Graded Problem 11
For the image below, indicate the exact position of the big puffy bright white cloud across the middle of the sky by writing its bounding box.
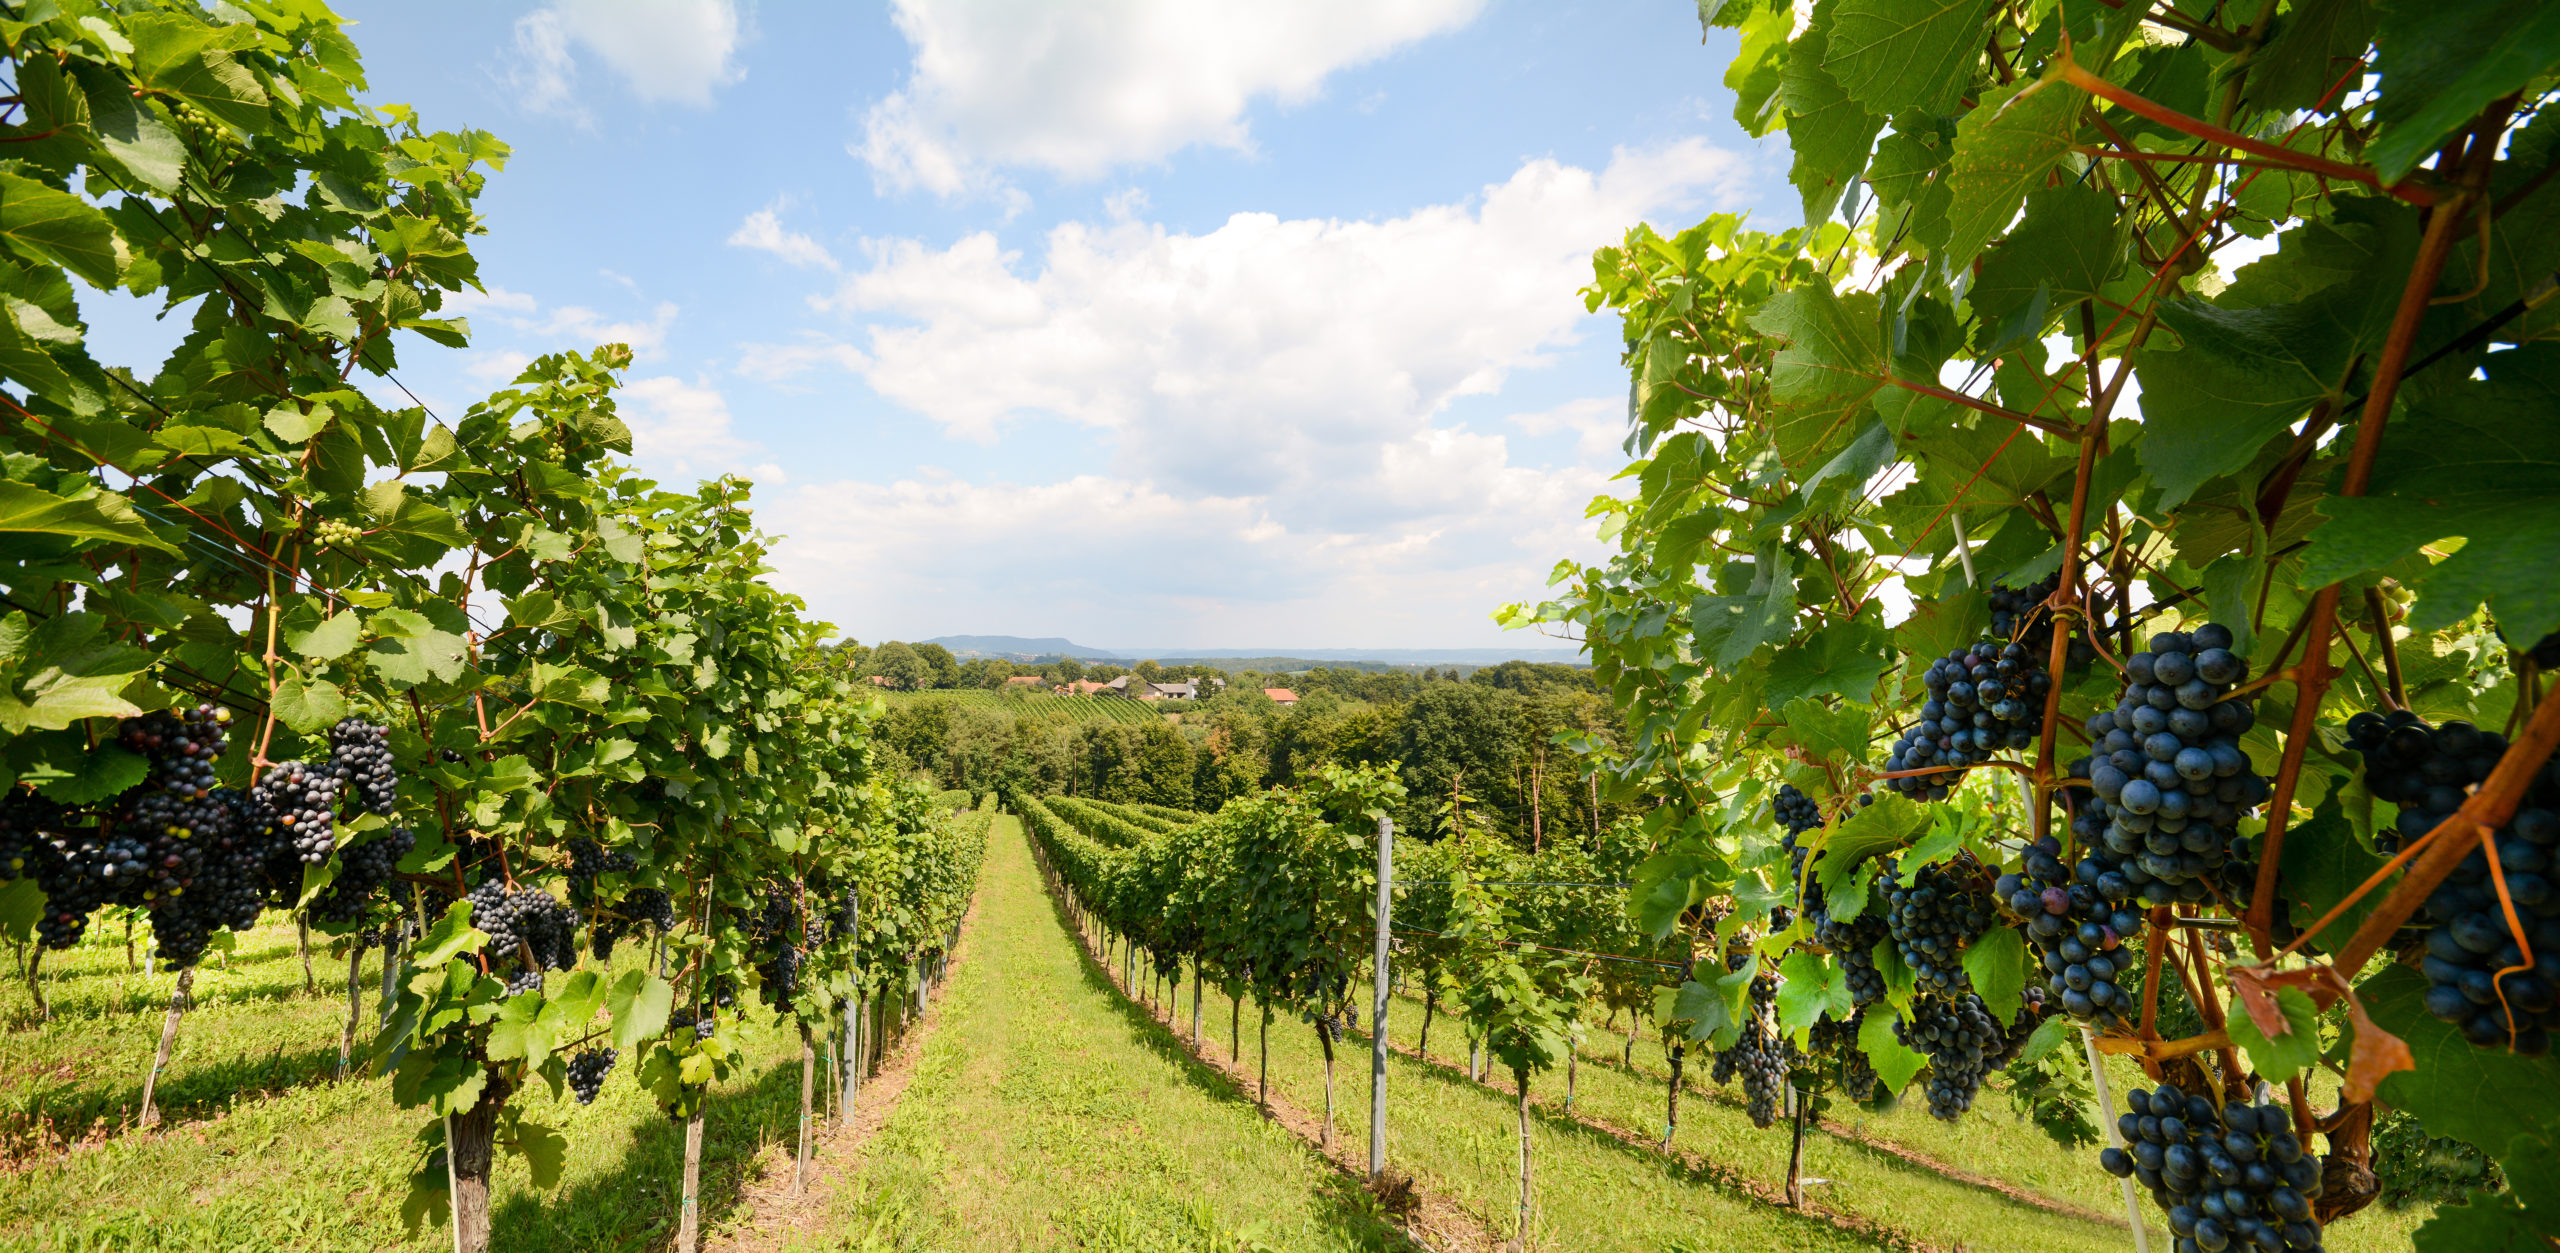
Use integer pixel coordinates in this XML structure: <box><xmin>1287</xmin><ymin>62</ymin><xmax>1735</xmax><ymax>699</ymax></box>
<box><xmin>827</xmin><ymin>141</ymin><xmax>1746</xmax><ymax>500</ymax></box>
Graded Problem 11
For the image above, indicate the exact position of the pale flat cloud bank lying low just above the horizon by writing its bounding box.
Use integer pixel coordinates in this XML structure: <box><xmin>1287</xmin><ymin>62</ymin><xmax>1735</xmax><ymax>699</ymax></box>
<box><xmin>758</xmin><ymin>441</ymin><xmax>1608</xmax><ymax>648</ymax></box>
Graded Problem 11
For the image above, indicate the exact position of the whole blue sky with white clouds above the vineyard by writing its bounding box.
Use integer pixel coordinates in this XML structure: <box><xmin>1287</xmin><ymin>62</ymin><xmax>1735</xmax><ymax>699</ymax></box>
<box><xmin>280</xmin><ymin>0</ymin><xmax>1797</xmax><ymax>648</ymax></box>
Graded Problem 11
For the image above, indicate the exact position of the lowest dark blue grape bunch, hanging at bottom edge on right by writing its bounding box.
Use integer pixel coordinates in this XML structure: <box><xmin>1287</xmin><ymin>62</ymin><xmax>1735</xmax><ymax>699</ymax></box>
<box><xmin>2097</xmin><ymin>1084</ymin><xmax>2319</xmax><ymax>1253</ymax></box>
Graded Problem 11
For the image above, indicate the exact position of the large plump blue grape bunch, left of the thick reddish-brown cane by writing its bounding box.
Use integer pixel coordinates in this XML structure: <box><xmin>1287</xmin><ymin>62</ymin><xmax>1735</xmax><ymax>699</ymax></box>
<box><xmin>2071</xmin><ymin>623</ymin><xmax>2273</xmax><ymax>905</ymax></box>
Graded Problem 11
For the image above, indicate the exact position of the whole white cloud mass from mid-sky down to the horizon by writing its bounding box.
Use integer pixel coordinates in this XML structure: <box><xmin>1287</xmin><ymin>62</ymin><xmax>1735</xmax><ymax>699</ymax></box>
<box><xmin>740</xmin><ymin>141</ymin><xmax>1746</xmax><ymax>646</ymax></box>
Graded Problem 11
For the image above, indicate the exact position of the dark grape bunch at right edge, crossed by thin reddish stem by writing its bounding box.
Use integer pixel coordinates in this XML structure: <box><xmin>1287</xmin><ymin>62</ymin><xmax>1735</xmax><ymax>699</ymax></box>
<box><xmin>2419</xmin><ymin>758</ymin><xmax>2560</xmax><ymax>1056</ymax></box>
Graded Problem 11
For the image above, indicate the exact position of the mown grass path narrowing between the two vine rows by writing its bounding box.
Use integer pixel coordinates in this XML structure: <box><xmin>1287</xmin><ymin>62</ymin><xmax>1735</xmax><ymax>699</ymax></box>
<box><xmin>794</xmin><ymin>817</ymin><xmax>1398</xmax><ymax>1253</ymax></box>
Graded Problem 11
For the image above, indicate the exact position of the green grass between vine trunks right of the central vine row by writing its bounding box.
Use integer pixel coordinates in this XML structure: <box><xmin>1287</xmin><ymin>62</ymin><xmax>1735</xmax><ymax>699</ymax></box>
<box><xmin>1185</xmin><ymin>989</ymin><xmax>2427</xmax><ymax>1253</ymax></box>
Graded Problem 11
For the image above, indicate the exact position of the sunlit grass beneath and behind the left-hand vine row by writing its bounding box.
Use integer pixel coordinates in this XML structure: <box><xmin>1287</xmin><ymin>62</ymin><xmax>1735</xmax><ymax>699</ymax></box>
<box><xmin>0</xmin><ymin>915</ymin><xmax>844</xmax><ymax>1253</ymax></box>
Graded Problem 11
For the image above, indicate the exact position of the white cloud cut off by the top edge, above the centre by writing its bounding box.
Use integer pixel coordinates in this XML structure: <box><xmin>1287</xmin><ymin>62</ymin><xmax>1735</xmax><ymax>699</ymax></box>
<box><xmin>850</xmin><ymin>0</ymin><xmax>1482</xmax><ymax>195</ymax></box>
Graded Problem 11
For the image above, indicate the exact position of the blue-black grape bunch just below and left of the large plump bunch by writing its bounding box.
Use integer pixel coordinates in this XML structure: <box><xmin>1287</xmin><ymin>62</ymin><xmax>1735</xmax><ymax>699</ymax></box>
<box><xmin>1992</xmin><ymin>835</ymin><xmax>2143</xmax><ymax>1022</ymax></box>
